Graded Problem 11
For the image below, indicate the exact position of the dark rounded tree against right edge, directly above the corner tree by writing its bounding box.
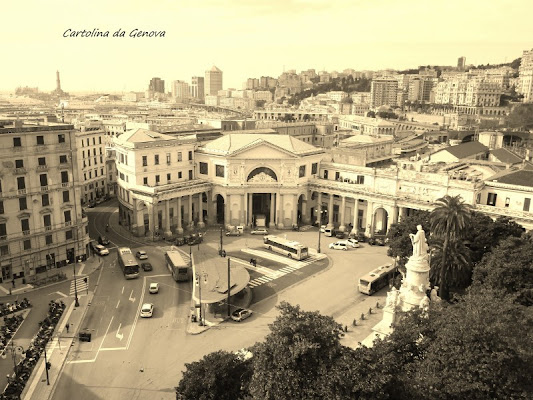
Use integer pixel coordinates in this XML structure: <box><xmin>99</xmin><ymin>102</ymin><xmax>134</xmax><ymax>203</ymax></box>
<box><xmin>472</xmin><ymin>234</ymin><xmax>533</xmax><ymax>306</ymax></box>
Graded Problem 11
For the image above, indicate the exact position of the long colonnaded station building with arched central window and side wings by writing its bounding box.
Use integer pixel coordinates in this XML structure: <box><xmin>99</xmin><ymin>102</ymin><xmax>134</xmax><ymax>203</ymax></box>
<box><xmin>114</xmin><ymin>129</ymin><xmax>533</xmax><ymax>239</ymax></box>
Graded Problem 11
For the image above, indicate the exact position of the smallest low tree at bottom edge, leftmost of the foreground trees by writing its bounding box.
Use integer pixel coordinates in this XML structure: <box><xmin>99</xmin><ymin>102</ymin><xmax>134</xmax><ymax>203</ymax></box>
<box><xmin>176</xmin><ymin>351</ymin><xmax>252</xmax><ymax>400</ymax></box>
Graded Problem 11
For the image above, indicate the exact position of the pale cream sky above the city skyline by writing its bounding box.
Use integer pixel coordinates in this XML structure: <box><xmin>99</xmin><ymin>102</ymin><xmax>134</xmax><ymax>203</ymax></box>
<box><xmin>0</xmin><ymin>0</ymin><xmax>533</xmax><ymax>93</ymax></box>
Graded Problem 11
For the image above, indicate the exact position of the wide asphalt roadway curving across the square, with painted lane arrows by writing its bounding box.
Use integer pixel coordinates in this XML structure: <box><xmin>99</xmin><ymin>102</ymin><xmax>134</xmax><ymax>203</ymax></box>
<box><xmin>53</xmin><ymin>203</ymin><xmax>389</xmax><ymax>400</ymax></box>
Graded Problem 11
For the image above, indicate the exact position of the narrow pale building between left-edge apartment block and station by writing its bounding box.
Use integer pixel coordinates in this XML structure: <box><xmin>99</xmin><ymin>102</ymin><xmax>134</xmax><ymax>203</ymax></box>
<box><xmin>76</xmin><ymin>121</ymin><xmax>108</xmax><ymax>204</ymax></box>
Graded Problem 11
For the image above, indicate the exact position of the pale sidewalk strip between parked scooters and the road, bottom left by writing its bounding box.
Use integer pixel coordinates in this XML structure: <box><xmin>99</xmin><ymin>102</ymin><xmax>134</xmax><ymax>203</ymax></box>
<box><xmin>21</xmin><ymin>292</ymin><xmax>94</xmax><ymax>400</ymax></box>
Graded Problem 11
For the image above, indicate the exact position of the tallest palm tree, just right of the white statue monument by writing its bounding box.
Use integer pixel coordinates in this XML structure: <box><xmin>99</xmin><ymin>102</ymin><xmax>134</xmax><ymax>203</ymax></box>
<box><xmin>430</xmin><ymin>195</ymin><xmax>472</xmax><ymax>300</ymax></box>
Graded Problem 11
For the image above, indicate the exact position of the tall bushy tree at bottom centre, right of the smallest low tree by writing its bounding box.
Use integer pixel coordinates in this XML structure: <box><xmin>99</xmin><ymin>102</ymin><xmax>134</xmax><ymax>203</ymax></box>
<box><xmin>250</xmin><ymin>302</ymin><xmax>343</xmax><ymax>400</ymax></box>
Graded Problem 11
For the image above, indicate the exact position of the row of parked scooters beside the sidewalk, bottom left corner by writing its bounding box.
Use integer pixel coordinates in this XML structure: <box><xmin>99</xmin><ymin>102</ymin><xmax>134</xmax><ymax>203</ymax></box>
<box><xmin>0</xmin><ymin>301</ymin><xmax>65</xmax><ymax>400</ymax></box>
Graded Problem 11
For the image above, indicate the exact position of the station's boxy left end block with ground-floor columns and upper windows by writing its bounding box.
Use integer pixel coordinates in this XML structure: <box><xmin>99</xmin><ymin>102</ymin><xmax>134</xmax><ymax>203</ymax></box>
<box><xmin>114</xmin><ymin>129</ymin><xmax>203</xmax><ymax>237</ymax></box>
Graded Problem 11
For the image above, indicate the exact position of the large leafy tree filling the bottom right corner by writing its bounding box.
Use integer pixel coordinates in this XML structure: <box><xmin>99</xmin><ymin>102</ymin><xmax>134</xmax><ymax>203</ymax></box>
<box><xmin>404</xmin><ymin>290</ymin><xmax>533</xmax><ymax>400</ymax></box>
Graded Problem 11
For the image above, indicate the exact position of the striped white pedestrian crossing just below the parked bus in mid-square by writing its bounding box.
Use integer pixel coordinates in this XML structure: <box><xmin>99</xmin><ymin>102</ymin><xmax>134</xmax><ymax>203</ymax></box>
<box><xmin>239</xmin><ymin>249</ymin><xmax>326</xmax><ymax>288</ymax></box>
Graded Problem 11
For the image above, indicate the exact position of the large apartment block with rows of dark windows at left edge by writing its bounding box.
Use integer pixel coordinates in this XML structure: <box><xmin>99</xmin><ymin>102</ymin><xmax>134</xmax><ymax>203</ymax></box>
<box><xmin>0</xmin><ymin>120</ymin><xmax>89</xmax><ymax>282</ymax></box>
